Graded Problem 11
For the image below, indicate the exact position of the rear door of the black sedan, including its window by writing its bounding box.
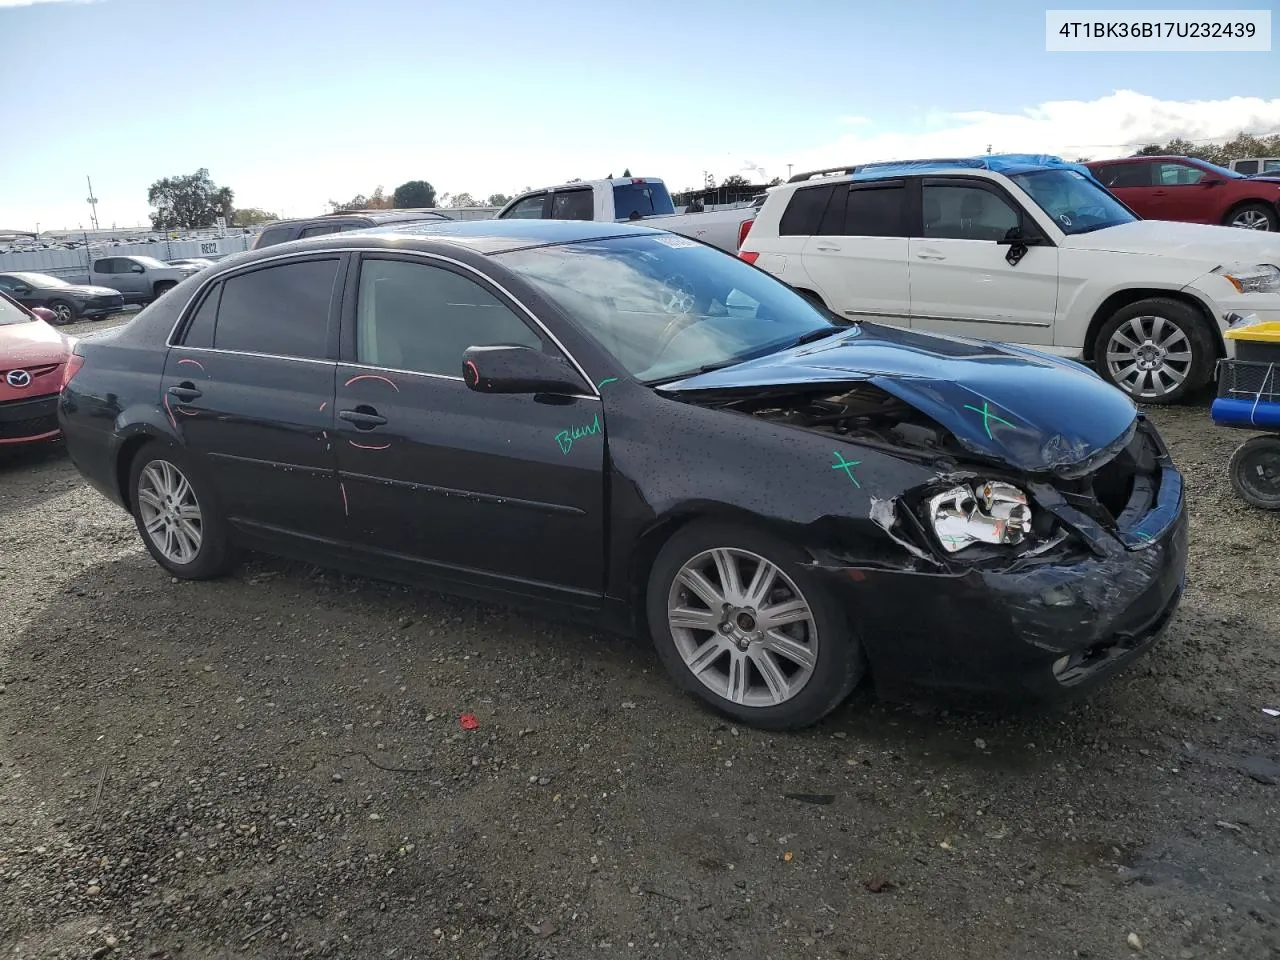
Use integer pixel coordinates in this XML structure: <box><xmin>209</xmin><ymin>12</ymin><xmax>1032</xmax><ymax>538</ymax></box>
<box><xmin>161</xmin><ymin>253</ymin><xmax>344</xmax><ymax>540</ymax></box>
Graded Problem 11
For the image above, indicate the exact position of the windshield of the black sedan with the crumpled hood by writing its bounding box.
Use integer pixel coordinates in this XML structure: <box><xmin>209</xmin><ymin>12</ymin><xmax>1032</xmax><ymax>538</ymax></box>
<box><xmin>494</xmin><ymin>234</ymin><xmax>849</xmax><ymax>384</ymax></box>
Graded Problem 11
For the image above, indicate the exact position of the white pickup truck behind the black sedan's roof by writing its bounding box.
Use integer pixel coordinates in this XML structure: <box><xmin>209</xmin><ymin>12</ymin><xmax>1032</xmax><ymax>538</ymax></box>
<box><xmin>497</xmin><ymin>177</ymin><xmax>758</xmax><ymax>253</ymax></box>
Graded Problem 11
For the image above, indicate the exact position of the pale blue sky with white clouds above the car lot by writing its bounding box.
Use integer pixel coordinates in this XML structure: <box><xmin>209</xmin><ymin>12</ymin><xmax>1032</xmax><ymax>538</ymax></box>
<box><xmin>0</xmin><ymin>0</ymin><xmax>1280</xmax><ymax>229</ymax></box>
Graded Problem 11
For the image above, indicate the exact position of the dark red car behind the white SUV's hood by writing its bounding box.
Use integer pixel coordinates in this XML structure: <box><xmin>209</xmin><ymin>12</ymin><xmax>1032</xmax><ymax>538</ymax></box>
<box><xmin>1085</xmin><ymin>156</ymin><xmax>1280</xmax><ymax>230</ymax></box>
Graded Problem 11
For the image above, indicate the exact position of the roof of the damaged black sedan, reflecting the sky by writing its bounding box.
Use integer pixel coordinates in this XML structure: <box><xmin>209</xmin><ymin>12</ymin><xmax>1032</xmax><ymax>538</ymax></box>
<box><xmin>237</xmin><ymin>219</ymin><xmax>666</xmax><ymax>264</ymax></box>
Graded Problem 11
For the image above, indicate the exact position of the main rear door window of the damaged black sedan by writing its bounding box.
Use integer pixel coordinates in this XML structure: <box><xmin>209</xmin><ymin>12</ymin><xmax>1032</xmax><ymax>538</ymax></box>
<box><xmin>214</xmin><ymin>259</ymin><xmax>339</xmax><ymax>360</ymax></box>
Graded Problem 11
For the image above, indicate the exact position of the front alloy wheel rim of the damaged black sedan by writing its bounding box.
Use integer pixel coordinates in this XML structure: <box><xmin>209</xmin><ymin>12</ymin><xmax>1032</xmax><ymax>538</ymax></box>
<box><xmin>667</xmin><ymin>548</ymin><xmax>818</xmax><ymax>707</ymax></box>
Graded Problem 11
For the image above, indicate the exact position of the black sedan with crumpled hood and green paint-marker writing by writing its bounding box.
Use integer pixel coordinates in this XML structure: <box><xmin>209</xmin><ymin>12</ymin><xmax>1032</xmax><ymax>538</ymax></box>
<box><xmin>59</xmin><ymin>220</ymin><xmax>1187</xmax><ymax>728</ymax></box>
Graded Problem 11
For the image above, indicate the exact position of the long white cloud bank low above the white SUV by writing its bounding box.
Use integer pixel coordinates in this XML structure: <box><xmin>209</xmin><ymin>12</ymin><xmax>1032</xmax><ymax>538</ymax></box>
<box><xmin>756</xmin><ymin>90</ymin><xmax>1280</xmax><ymax>181</ymax></box>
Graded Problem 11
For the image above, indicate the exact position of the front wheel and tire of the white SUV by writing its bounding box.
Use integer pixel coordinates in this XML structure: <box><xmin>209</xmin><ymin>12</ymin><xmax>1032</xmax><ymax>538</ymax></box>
<box><xmin>1093</xmin><ymin>297</ymin><xmax>1215</xmax><ymax>404</ymax></box>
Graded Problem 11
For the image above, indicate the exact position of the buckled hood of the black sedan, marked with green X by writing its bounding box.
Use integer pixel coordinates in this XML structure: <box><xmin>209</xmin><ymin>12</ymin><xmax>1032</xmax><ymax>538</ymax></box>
<box><xmin>658</xmin><ymin>324</ymin><xmax>1137</xmax><ymax>472</ymax></box>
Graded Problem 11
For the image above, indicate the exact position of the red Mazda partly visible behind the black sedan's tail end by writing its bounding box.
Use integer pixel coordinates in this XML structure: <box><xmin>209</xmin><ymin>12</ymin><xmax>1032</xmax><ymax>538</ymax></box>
<box><xmin>0</xmin><ymin>293</ymin><xmax>72</xmax><ymax>447</ymax></box>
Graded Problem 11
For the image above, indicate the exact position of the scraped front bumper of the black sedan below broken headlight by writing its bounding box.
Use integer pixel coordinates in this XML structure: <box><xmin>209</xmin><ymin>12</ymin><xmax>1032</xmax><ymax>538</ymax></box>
<box><xmin>817</xmin><ymin>448</ymin><xmax>1188</xmax><ymax>703</ymax></box>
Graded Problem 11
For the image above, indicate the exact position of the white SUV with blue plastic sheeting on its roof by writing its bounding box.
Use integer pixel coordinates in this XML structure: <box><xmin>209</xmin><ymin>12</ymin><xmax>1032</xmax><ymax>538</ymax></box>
<box><xmin>739</xmin><ymin>155</ymin><xmax>1280</xmax><ymax>403</ymax></box>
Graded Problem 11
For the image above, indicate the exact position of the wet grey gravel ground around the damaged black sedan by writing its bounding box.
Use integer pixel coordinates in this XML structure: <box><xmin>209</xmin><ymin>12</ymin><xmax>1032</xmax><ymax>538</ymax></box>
<box><xmin>0</xmin><ymin>317</ymin><xmax>1280</xmax><ymax>960</ymax></box>
